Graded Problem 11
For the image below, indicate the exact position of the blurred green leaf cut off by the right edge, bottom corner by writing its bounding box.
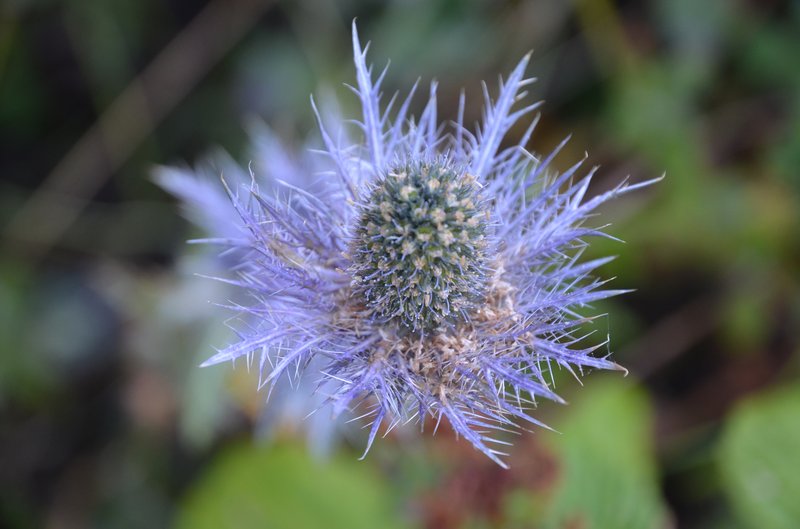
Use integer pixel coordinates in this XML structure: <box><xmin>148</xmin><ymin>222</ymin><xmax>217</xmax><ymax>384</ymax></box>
<box><xmin>720</xmin><ymin>385</ymin><xmax>800</xmax><ymax>529</ymax></box>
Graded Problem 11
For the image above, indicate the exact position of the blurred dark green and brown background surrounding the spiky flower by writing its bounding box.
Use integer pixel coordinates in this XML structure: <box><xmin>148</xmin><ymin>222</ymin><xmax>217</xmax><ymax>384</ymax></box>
<box><xmin>0</xmin><ymin>0</ymin><xmax>800</xmax><ymax>529</ymax></box>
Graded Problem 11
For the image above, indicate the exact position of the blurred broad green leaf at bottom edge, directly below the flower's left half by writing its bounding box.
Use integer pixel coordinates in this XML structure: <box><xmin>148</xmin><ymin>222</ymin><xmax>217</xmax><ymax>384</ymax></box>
<box><xmin>176</xmin><ymin>445</ymin><xmax>412</xmax><ymax>529</ymax></box>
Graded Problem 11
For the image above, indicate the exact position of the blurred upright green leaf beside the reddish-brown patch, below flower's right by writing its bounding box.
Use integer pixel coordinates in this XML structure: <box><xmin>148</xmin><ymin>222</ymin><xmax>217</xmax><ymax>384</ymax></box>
<box><xmin>543</xmin><ymin>377</ymin><xmax>669</xmax><ymax>529</ymax></box>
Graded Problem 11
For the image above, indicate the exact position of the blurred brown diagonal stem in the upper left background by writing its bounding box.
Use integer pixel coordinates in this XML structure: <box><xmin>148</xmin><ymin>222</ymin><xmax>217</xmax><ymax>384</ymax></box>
<box><xmin>5</xmin><ymin>0</ymin><xmax>272</xmax><ymax>257</ymax></box>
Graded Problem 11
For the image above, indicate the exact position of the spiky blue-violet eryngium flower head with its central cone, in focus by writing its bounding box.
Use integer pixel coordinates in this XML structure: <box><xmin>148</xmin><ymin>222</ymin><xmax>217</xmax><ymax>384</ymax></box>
<box><xmin>169</xmin><ymin>25</ymin><xmax>650</xmax><ymax>466</ymax></box>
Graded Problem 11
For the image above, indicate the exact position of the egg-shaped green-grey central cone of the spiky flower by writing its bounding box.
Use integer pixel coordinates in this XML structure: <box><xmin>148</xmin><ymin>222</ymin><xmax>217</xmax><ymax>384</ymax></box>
<box><xmin>350</xmin><ymin>162</ymin><xmax>488</xmax><ymax>333</ymax></box>
